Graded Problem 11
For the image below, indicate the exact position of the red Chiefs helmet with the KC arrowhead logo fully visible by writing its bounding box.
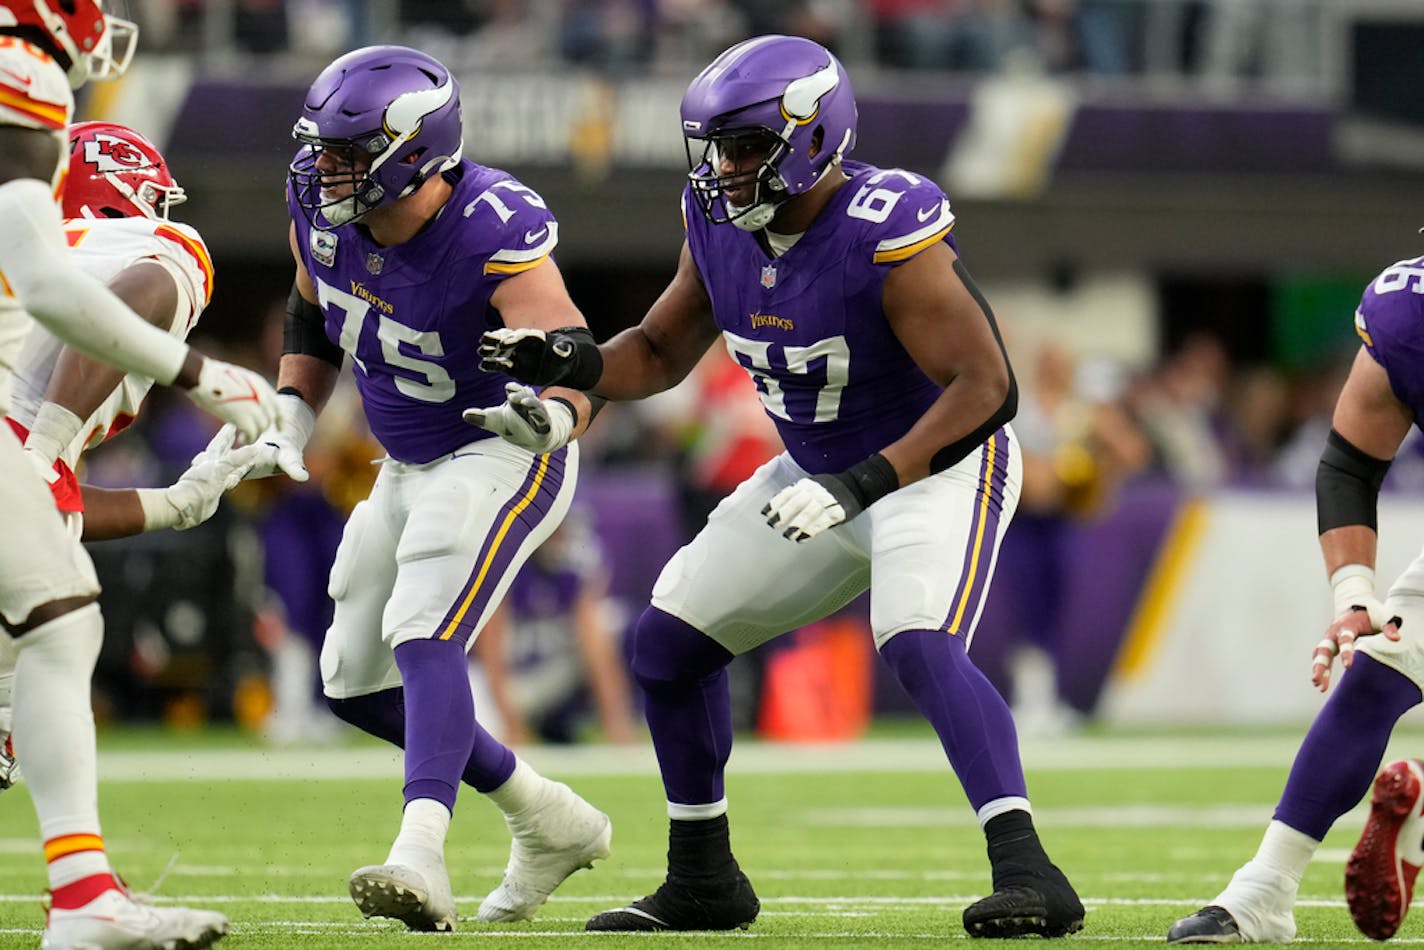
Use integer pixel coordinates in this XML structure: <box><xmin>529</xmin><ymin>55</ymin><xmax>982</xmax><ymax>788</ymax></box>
<box><xmin>60</xmin><ymin>122</ymin><xmax>188</xmax><ymax>221</ymax></box>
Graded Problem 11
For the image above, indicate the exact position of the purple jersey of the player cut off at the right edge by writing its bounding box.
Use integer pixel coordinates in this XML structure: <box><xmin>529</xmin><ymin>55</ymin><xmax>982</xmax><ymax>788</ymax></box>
<box><xmin>1354</xmin><ymin>258</ymin><xmax>1424</xmax><ymax>420</ymax></box>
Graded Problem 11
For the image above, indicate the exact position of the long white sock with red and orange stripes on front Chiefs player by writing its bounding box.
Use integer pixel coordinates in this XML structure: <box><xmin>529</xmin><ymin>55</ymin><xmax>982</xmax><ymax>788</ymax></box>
<box><xmin>13</xmin><ymin>604</ymin><xmax>110</xmax><ymax>889</ymax></box>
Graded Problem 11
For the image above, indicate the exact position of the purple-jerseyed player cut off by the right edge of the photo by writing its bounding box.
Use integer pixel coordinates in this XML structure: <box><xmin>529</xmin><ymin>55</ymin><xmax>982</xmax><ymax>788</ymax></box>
<box><xmin>1168</xmin><ymin>258</ymin><xmax>1424</xmax><ymax>943</ymax></box>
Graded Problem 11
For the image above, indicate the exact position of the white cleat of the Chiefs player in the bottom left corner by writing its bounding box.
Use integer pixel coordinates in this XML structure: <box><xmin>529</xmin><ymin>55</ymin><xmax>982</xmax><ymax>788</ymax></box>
<box><xmin>40</xmin><ymin>890</ymin><xmax>228</xmax><ymax>950</ymax></box>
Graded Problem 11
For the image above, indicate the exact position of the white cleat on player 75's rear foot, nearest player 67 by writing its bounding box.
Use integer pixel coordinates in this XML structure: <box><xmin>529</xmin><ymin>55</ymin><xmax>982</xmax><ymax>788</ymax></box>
<box><xmin>478</xmin><ymin>781</ymin><xmax>614</xmax><ymax>923</ymax></box>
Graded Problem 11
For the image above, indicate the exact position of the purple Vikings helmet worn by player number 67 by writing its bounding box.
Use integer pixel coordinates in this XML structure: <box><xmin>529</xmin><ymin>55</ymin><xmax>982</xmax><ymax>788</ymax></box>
<box><xmin>682</xmin><ymin>36</ymin><xmax>856</xmax><ymax>231</ymax></box>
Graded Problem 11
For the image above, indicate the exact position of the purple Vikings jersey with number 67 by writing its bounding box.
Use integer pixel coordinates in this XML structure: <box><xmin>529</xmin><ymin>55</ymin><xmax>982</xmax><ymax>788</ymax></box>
<box><xmin>682</xmin><ymin>161</ymin><xmax>954</xmax><ymax>474</ymax></box>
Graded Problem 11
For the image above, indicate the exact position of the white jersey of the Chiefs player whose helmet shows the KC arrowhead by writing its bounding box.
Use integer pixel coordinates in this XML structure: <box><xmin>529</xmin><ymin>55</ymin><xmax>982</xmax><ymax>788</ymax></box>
<box><xmin>10</xmin><ymin>218</ymin><xmax>212</xmax><ymax>467</ymax></box>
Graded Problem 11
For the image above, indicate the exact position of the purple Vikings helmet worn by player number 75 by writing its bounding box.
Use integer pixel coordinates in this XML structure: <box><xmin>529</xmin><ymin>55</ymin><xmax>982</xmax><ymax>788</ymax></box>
<box><xmin>290</xmin><ymin>46</ymin><xmax>464</xmax><ymax>226</ymax></box>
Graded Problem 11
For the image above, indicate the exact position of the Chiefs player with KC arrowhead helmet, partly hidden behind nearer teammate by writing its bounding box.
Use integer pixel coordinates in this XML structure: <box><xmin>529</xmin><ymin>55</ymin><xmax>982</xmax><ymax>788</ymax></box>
<box><xmin>0</xmin><ymin>122</ymin><xmax>256</xmax><ymax>789</ymax></box>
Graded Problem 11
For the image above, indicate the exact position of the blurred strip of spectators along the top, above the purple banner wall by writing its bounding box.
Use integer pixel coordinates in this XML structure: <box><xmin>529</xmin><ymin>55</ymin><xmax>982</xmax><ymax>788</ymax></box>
<box><xmin>131</xmin><ymin>0</ymin><xmax>1324</xmax><ymax>87</ymax></box>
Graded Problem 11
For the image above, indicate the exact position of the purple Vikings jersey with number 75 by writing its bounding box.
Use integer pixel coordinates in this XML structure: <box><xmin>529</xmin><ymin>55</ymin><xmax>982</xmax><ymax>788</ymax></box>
<box><xmin>288</xmin><ymin>160</ymin><xmax>558</xmax><ymax>463</ymax></box>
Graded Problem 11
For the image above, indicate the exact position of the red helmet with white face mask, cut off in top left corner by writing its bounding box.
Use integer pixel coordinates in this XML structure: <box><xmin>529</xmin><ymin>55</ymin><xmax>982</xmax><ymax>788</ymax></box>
<box><xmin>0</xmin><ymin>0</ymin><xmax>138</xmax><ymax>88</ymax></box>
